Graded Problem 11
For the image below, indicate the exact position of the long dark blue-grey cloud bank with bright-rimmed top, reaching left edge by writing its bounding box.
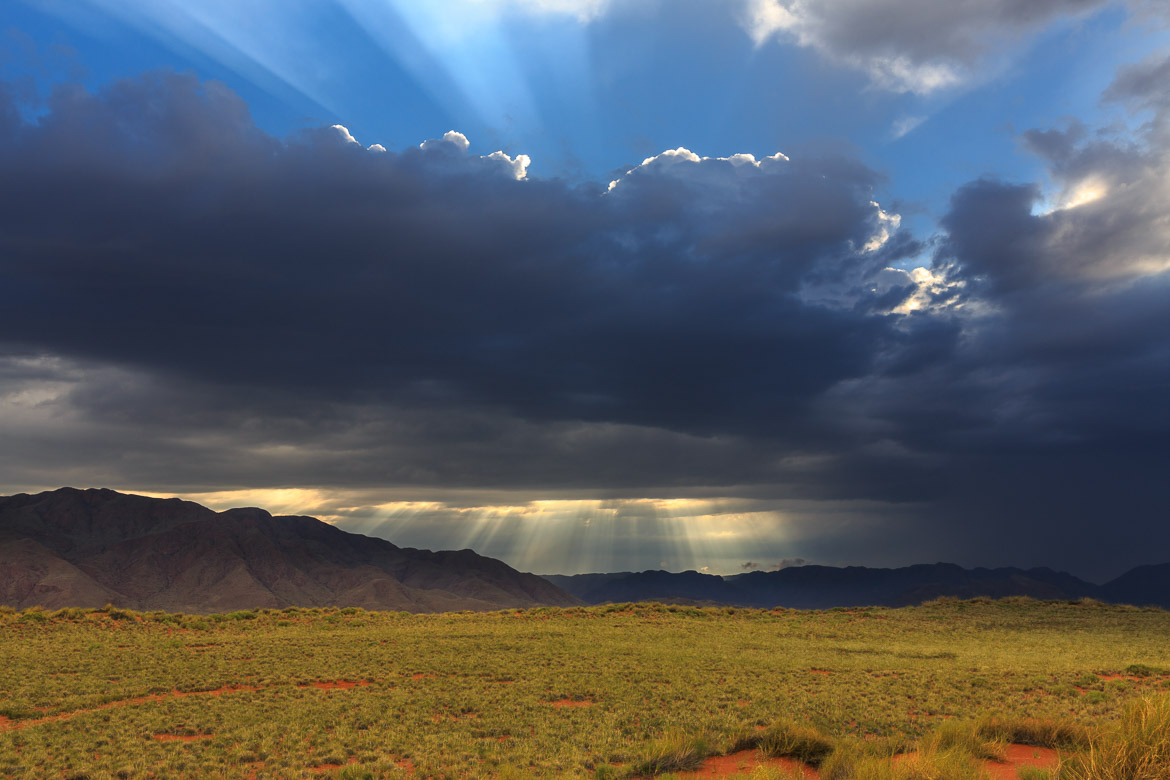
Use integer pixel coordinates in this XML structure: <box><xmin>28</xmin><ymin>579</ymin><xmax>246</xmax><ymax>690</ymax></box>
<box><xmin>0</xmin><ymin>74</ymin><xmax>903</xmax><ymax>444</ymax></box>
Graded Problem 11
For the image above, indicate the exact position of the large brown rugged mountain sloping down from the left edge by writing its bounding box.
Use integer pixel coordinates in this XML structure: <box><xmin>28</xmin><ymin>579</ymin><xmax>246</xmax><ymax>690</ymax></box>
<box><xmin>0</xmin><ymin>488</ymin><xmax>580</xmax><ymax>613</ymax></box>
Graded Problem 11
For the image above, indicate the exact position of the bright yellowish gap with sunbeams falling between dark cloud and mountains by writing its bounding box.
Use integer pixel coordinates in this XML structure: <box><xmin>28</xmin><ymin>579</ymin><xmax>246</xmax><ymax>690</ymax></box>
<box><xmin>140</xmin><ymin>489</ymin><xmax>787</xmax><ymax>574</ymax></box>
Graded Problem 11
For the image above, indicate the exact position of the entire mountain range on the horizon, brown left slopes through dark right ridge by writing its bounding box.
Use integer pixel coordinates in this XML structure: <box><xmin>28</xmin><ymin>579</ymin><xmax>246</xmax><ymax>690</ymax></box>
<box><xmin>0</xmin><ymin>488</ymin><xmax>1170</xmax><ymax>613</ymax></box>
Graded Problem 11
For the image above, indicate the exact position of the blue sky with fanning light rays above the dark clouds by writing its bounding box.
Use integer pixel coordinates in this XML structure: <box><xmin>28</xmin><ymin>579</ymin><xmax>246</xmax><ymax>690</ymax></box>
<box><xmin>0</xmin><ymin>0</ymin><xmax>1170</xmax><ymax>206</ymax></box>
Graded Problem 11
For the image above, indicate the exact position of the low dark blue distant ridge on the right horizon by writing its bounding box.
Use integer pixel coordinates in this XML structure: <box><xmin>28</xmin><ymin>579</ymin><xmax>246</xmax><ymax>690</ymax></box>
<box><xmin>545</xmin><ymin>564</ymin><xmax>1170</xmax><ymax>609</ymax></box>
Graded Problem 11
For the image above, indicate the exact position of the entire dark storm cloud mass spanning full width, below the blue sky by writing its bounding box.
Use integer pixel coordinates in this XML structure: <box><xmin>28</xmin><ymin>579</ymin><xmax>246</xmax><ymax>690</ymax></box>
<box><xmin>0</xmin><ymin>68</ymin><xmax>1170</xmax><ymax>574</ymax></box>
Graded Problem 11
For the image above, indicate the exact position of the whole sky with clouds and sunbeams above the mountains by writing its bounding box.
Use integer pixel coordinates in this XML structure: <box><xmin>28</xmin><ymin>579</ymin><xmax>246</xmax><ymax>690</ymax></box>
<box><xmin>0</xmin><ymin>0</ymin><xmax>1170</xmax><ymax>581</ymax></box>
